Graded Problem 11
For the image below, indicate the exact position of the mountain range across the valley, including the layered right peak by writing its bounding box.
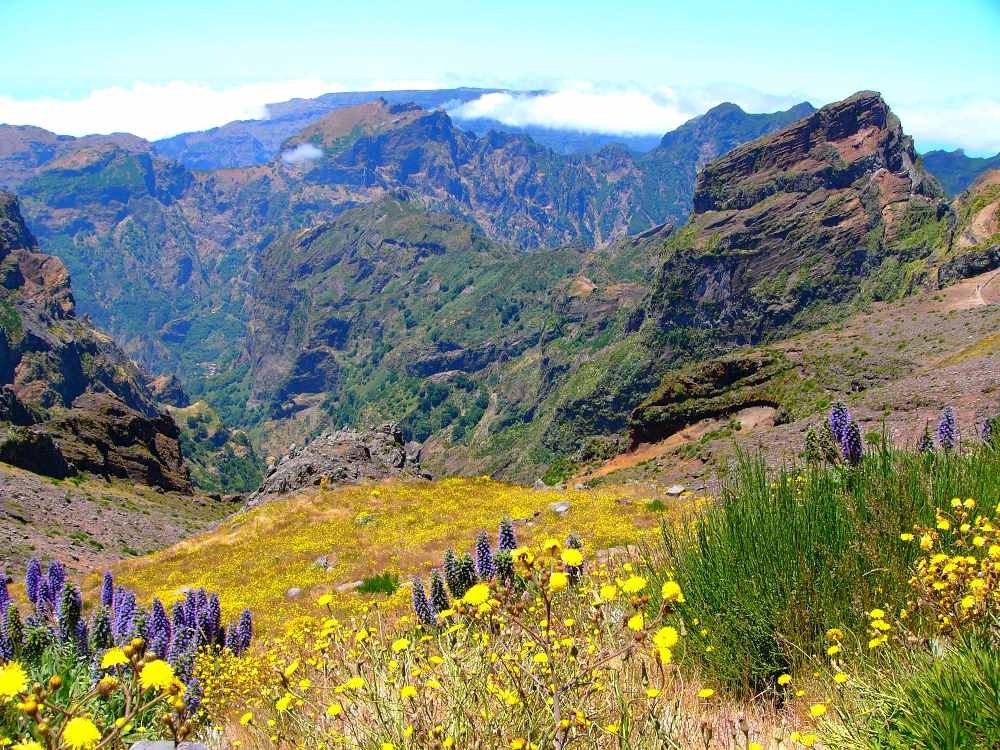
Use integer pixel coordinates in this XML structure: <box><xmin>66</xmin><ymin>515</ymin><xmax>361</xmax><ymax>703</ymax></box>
<box><xmin>0</xmin><ymin>90</ymin><xmax>1000</xmax><ymax>490</ymax></box>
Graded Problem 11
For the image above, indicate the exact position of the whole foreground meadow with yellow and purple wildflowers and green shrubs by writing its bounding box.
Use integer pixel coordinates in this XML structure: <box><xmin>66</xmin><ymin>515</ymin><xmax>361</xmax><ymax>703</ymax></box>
<box><xmin>0</xmin><ymin>404</ymin><xmax>1000</xmax><ymax>750</ymax></box>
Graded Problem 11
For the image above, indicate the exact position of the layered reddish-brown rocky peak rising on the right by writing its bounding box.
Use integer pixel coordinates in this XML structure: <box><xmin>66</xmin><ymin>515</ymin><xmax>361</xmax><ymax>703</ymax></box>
<box><xmin>649</xmin><ymin>92</ymin><xmax>948</xmax><ymax>343</ymax></box>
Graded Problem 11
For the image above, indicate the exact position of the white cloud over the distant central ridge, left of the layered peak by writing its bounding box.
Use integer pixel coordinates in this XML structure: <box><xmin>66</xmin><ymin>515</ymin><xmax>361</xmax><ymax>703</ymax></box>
<box><xmin>452</xmin><ymin>82</ymin><xmax>804</xmax><ymax>135</ymax></box>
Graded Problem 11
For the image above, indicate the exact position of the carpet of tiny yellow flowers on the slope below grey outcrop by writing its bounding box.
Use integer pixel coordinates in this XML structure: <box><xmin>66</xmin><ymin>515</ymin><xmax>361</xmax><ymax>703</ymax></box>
<box><xmin>105</xmin><ymin>477</ymin><xmax>700</xmax><ymax>633</ymax></box>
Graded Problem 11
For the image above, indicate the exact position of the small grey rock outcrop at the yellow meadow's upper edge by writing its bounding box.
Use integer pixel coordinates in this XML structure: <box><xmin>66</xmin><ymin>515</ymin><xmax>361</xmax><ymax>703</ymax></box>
<box><xmin>247</xmin><ymin>424</ymin><xmax>428</xmax><ymax>507</ymax></box>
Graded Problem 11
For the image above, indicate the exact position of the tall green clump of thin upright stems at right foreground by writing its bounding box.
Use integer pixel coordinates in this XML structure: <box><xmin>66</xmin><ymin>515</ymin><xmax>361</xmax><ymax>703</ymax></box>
<box><xmin>654</xmin><ymin>441</ymin><xmax>1000</xmax><ymax>695</ymax></box>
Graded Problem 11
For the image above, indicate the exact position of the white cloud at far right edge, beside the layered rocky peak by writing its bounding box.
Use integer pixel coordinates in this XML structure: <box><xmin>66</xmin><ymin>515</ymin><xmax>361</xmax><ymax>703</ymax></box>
<box><xmin>893</xmin><ymin>99</ymin><xmax>1000</xmax><ymax>155</ymax></box>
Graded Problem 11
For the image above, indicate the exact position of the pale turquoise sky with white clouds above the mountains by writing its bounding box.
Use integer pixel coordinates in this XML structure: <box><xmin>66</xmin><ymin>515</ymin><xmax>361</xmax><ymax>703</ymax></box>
<box><xmin>0</xmin><ymin>0</ymin><xmax>1000</xmax><ymax>153</ymax></box>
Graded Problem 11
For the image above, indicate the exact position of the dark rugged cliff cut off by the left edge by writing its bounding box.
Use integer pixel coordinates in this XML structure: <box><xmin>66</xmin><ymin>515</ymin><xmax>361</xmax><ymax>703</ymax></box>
<box><xmin>0</xmin><ymin>193</ymin><xmax>191</xmax><ymax>491</ymax></box>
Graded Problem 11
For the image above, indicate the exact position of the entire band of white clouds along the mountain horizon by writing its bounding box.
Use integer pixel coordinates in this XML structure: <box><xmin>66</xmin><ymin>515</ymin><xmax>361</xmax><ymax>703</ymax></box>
<box><xmin>0</xmin><ymin>79</ymin><xmax>1000</xmax><ymax>155</ymax></box>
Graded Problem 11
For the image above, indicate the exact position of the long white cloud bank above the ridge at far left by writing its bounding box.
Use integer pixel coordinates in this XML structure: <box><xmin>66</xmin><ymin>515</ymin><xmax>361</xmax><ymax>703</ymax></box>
<box><xmin>0</xmin><ymin>79</ymin><xmax>343</xmax><ymax>140</ymax></box>
